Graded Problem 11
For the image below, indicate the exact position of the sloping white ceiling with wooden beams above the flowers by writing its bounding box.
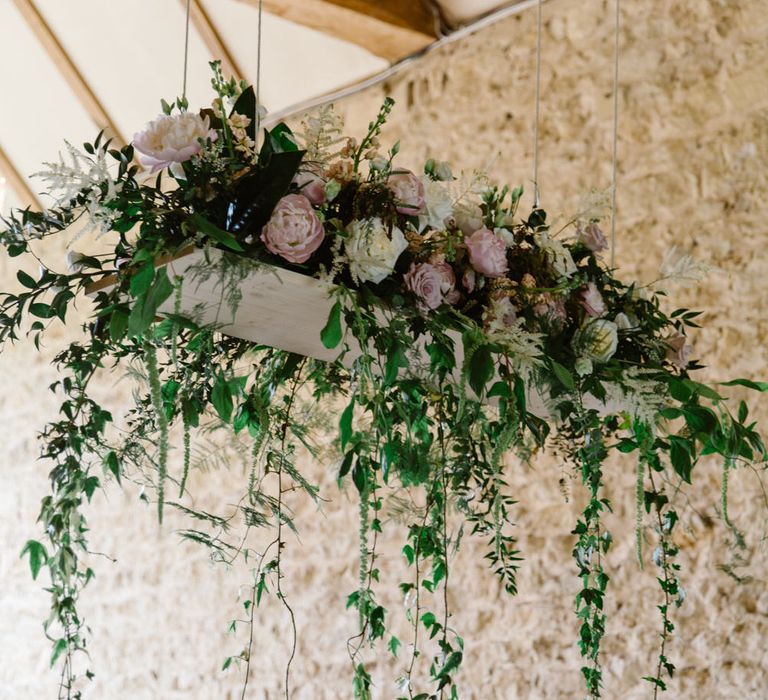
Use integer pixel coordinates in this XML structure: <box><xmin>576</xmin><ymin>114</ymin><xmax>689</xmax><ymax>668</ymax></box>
<box><xmin>0</xmin><ymin>0</ymin><xmax>514</xmax><ymax>212</ymax></box>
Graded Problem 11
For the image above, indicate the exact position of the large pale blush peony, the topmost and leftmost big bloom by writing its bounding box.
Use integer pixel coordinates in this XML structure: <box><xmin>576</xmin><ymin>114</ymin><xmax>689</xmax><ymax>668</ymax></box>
<box><xmin>133</xmin><ymin>112</ymin><xmax>216</xmax><ymax>178</ymax></box>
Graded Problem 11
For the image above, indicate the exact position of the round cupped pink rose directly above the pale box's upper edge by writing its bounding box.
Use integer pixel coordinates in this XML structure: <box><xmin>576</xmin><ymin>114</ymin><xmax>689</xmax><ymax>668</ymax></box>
<box><xmin>261</xmin><ymin>194</ymin><xmax>325</xmax><ymax>263</ymax></box>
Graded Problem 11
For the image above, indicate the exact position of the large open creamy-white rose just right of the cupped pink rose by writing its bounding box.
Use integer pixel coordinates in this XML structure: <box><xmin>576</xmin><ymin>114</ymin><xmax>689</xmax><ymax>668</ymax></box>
<box><xmin>345</xmin><ymin>217</ymin><xmax>408</xmax><ymax>284</ymax></box>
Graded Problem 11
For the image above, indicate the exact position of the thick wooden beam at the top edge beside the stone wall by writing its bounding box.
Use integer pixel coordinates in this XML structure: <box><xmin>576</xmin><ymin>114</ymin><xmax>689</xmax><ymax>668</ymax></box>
<box><xmin>241</xmin><ymin>0</ymin><xmax>435</xmax><ymax>63</ymax></box>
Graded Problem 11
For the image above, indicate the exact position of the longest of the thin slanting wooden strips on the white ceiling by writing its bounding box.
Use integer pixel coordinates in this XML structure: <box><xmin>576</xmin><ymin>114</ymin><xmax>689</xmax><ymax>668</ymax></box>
<box><xmin>13</xmin><ymin>0</ymin><xmax>125</xmax><ymax>145</ymax></box>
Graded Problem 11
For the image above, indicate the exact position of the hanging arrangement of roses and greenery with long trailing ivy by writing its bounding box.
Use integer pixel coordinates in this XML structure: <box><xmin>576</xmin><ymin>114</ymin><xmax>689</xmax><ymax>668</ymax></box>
<box><xmin>0</xmin><ymin>64</ymin><xmax>768</xmax><ymax>700</ymax></box>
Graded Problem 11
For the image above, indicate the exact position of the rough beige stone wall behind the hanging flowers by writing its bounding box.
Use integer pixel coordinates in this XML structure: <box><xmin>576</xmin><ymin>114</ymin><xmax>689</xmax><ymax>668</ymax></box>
<box><xmin>0</xmin><ymin>0</ymin><xmax>768</xmax><ymax>700</ymax></box>
